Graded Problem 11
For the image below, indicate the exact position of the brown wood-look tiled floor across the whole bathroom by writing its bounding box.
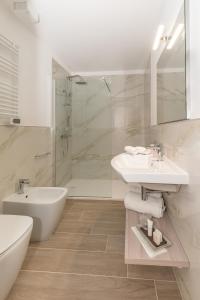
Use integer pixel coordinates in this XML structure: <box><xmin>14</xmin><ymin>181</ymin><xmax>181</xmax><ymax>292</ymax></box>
<box><xmin>7</xmin><ymin>200</ymin><xmax>181</xmax><ymax>300</ymax></box>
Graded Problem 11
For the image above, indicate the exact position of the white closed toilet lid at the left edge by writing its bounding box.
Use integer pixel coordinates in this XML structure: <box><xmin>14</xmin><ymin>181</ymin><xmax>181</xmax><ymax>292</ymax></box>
<box><xmin>0</xmin><ymin>215</ymin><xmax>33</xmax><ymax>255</ymax></box>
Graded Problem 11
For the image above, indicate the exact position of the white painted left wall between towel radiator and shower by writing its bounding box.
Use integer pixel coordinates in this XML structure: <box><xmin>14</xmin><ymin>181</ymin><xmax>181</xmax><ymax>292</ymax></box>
<box><xmin>0</xmin><ymin>3</ymin><xmax>65</xmax><ymax>126</ymax></box>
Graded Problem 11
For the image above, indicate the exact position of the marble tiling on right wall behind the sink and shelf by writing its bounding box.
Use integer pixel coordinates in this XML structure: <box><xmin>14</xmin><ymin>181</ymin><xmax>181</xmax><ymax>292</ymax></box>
<box><xmin>146</xmin><ymin>120</ymin><xmax>200</xmax><ymax>300</ymax></box>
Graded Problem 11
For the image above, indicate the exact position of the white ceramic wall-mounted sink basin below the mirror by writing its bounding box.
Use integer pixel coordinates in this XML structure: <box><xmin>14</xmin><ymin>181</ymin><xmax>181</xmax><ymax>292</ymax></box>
<box><xmin>111</xmin><ymin>153</ymin><xmax>189</xmax><ymax>185</ymax></box>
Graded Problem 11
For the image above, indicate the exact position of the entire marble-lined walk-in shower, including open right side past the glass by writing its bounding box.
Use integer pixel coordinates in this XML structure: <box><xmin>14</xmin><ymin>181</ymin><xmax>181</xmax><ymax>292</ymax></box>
<box><xmin>54</xmin><ymin>62</ymin><xmax>145</xmax><ymax>199</ymax></box>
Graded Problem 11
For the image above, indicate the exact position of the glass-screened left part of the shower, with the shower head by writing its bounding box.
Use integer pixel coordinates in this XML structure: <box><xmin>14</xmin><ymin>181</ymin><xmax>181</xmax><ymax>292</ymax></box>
<box><xmin>54</xmin><ymin>75</ymin><xmax>112</xmax><ymax>198</ymax></box>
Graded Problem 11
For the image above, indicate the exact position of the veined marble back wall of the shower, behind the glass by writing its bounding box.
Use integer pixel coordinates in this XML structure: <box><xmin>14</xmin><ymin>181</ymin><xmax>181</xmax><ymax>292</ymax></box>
<box><xmin>72</xmin><ymin>75</ymin><xmax>144</xmax><ymax>185</ymax></box>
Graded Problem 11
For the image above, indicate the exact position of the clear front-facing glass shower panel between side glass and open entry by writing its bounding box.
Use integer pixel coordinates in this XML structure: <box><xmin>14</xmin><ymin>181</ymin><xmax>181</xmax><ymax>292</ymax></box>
<box><xmin>70</xmin><ymin>77</ymin><xmax>112</xmax><ymax>198</ymax></box>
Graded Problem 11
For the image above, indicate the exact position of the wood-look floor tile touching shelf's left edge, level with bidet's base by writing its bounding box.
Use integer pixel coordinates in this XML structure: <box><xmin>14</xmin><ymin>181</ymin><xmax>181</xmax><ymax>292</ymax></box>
<box><xmin>91</xmin><ymin>222</ymin><xmax>125</xmax><ymax>235</ymax></box>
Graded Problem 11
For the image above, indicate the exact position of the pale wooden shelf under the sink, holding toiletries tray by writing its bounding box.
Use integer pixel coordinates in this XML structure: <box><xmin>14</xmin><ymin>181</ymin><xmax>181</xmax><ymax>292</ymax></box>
<box><xmin>125</xmin><ymin>210</ymin><xmax>190</xmax><ymax>268</ymax></box>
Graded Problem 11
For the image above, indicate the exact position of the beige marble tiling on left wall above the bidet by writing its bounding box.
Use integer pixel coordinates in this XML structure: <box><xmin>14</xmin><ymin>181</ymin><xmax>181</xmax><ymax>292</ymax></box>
<box><xmin>0</xmin><ymin>126</ymin><xmax>53</xmax><ymax>210</ymax></box>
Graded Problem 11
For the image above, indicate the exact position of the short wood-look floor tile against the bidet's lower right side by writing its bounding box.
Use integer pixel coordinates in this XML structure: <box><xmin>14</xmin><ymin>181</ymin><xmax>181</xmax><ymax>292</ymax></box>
<box><xmin>56</xmin><ymin>220</ymin><xmax>93</xmax><ymax>233</ymax></box>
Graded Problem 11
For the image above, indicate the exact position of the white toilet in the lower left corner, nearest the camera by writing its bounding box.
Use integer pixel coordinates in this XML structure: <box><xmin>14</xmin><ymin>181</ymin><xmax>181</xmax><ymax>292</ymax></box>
<box><xmin>0</xmin><ymin>215</ymin><xmax>33</xmax><ymax>300</ymax></box>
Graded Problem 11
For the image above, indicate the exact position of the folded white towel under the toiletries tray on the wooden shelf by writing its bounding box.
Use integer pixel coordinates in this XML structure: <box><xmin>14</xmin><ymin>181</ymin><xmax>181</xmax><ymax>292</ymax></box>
<box><xmin>131</xmin><ymin>226</ymin><xmax>167</xmax><ymax>258</ymax></box>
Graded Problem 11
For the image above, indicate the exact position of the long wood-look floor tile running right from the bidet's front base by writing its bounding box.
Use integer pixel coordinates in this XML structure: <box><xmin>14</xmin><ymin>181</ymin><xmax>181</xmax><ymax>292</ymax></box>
<box><xmin>31</xmin><ymin>232</ymin><xmax>107</xmax><ymax>251</ymax></box>
